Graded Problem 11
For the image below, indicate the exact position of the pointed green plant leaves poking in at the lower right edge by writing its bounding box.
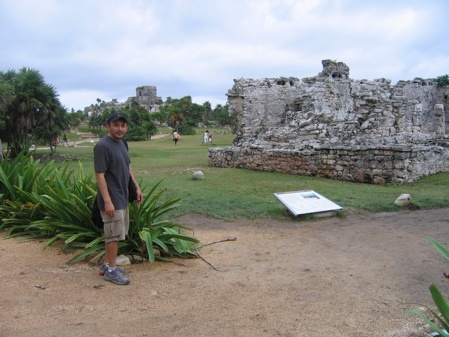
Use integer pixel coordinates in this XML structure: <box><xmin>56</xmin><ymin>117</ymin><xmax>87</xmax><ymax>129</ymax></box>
<box><xmin>407</xmin><ymin>237</ymin><xmax>449</xmax><ymax>337</ymax></box>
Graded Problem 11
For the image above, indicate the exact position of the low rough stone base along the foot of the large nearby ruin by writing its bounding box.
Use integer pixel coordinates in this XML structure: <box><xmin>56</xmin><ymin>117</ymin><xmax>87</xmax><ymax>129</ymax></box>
<box><xmin>209</xmin><ymin>144</ymin><xmax>449</xmax><ymax>184</ymax></box>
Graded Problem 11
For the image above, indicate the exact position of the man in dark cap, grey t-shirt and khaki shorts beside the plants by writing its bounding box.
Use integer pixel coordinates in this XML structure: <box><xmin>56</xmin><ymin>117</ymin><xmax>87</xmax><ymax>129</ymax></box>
<box><xmin>94</xmin><ymin>113</ymin><xmax>143</xmax><ymax>285</ymax></box>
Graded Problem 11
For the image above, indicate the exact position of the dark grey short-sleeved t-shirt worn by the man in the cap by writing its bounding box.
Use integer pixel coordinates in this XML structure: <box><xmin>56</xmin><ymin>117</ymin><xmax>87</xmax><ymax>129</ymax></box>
<box><xmin>94</xmin><ymin>136</ymin><xmax>131</xmax><ymax>211</ymax></box>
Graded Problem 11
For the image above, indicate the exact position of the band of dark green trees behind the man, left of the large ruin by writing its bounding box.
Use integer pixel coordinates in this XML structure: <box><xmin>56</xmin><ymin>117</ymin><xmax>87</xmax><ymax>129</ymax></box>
<box><xmin>0</xmin><ymin>67</ymin><xmax>235</xmax><ymax>157</ymax></box>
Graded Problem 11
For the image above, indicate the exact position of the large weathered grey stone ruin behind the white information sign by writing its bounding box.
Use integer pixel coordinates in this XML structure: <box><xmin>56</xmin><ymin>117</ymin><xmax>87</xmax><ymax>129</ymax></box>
<box><xmin>209</xmin><ymin>60</ymin><xmax>449</xmax><ymax>184</ymax></box>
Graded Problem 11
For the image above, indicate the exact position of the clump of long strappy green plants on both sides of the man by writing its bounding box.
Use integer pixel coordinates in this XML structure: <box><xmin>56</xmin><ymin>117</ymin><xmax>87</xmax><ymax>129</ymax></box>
<box><xmin>0</xmin><ymin>154</ymin><xmax>198</xmax><ymax>263</ymax></box>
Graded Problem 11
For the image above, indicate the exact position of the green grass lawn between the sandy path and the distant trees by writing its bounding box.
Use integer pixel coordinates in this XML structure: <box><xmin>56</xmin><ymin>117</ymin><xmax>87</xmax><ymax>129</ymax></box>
<box><xmin>34</xmin><ymin>129</ymin><xmax>449</xmax><ymax>220</ymax></box>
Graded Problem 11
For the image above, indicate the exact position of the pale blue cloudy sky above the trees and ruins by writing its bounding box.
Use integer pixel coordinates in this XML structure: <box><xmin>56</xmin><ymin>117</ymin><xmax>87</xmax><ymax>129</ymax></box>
<box><xmin>0</xmin><ymin>0</ymin><xmax>449</xmax><ymax>110</ymax></box>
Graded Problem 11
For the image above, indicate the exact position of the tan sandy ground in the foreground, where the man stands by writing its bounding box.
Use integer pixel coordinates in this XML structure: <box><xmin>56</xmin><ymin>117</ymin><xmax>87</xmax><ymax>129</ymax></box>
<box><xmin>0</xmin><ymin>209</ymin><xmax>449</xmax><ymax>337</ymax></box>
